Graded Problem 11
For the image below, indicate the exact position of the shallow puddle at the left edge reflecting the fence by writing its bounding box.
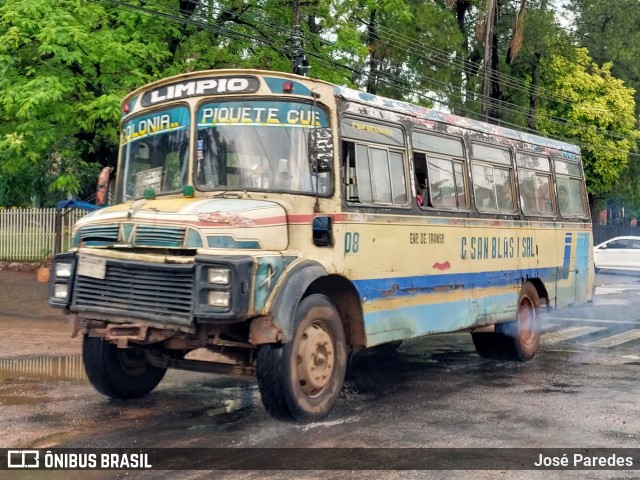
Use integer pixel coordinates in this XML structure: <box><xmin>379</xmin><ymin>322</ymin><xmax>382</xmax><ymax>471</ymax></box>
<box><xmin>0</xmin><ymin>355</ymin><xmax>88</xmax><ymax>382</ymax></box>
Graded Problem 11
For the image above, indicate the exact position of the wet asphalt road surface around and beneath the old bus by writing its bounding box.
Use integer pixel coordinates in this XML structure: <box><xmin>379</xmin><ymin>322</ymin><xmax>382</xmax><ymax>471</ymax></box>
<box><xmin>0</xmin><ymin>271</ymin><xmax>640</xmax><ymax>479</ymax></box>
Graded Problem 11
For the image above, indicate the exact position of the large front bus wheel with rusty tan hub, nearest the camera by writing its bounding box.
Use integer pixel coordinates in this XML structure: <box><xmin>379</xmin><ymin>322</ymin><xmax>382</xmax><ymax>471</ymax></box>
<box><xmin>257</xmin><ymin>294</ymin><xmax>347</xmax><ymax>421</ymax></box>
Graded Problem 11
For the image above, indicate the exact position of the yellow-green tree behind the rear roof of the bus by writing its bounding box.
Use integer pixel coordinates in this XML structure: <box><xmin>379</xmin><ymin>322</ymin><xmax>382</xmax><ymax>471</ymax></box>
<box><xmin>537</xmin><ymin>48</ymin><xmax>640</xmax><ymax>204</ymax></box>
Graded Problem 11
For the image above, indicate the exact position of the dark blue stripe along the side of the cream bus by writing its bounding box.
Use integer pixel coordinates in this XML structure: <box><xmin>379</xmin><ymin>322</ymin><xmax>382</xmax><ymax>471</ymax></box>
<box><xmin>353</xmin><ymin>267</ymin><xmax>556</xmax><ymax>302</ymax></box>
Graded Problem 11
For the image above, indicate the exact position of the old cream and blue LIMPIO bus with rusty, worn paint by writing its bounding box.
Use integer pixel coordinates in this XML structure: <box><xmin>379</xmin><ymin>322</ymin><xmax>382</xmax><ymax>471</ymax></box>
<box><xmin>49</xmin><ymin>69</ymin><xmax>594</xmax><ymax>421</ymax></box>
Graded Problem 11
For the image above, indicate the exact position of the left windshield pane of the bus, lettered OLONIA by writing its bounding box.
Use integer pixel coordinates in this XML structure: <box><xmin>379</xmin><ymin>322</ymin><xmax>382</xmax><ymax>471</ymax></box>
<box><xmin>121</xmin><ymin>106</ymin><xmax>189</xmax><ymax>201</ymax></box>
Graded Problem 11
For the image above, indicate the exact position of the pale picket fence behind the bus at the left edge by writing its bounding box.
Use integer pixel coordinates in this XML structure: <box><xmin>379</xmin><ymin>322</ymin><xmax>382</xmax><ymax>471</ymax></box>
<box><xmin>0</xmin><ymin>208</ymin><xmax>88</xmax><ymax>262</ymax></box>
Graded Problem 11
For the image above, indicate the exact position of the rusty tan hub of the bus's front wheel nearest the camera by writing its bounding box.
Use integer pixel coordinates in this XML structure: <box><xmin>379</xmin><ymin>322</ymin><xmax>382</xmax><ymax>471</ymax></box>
<box><xmin>297</xmin><ymin>323</ymin><xmax>335</xmax><ymax>397</ymax></box>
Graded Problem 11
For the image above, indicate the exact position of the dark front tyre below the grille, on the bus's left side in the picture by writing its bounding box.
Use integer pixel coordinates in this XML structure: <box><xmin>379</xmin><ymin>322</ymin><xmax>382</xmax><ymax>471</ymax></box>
<box><xmin>82</xmin><ymin>335</ymin><xmax>167</xmax><ymax>400</ymax></box>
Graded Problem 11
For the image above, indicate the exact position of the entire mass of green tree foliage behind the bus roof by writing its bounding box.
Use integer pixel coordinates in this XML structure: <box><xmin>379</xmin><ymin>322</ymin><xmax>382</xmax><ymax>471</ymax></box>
<box><xmin>0</xmin><ymin>0</ymin><xmax>640</xmax><ymax>210</ymax></box>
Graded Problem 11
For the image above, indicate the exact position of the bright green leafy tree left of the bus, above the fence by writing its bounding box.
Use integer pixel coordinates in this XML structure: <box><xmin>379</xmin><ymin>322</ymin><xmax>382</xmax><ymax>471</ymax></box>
<box><xmin>0</xmin><ymin>0</ymin><xmax>185</xmax><ymax>205</ymax></box>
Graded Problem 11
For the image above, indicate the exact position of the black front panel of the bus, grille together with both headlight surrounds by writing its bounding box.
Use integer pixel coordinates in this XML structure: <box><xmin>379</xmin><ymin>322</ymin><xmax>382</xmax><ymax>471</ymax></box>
<box><xmin>49</xmin><ymin>253</ymin><xmax>254</xmax><ymax>328</ymax></box>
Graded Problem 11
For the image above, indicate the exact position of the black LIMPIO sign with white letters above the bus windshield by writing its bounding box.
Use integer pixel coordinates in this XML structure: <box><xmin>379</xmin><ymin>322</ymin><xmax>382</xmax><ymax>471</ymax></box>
<box><xmin>141</xmin><ymin>76</ymin><xmax>260</xmax><ymax>107</ymax></box>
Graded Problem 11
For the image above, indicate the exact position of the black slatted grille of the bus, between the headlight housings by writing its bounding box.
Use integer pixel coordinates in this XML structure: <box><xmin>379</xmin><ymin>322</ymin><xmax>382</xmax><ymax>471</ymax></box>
<box><xmin>71</xmin><ymin>259</ymin><xmax>195</xmax><ymax>325</ymax></box>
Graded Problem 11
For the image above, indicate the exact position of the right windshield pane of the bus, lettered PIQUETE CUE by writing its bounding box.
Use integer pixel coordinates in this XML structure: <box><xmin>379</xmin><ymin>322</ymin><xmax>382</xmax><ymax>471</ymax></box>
<box><xmin>195</xmin><ymin>100</ymin><xmax>330</xmax><ymax>193</ymax></box>
